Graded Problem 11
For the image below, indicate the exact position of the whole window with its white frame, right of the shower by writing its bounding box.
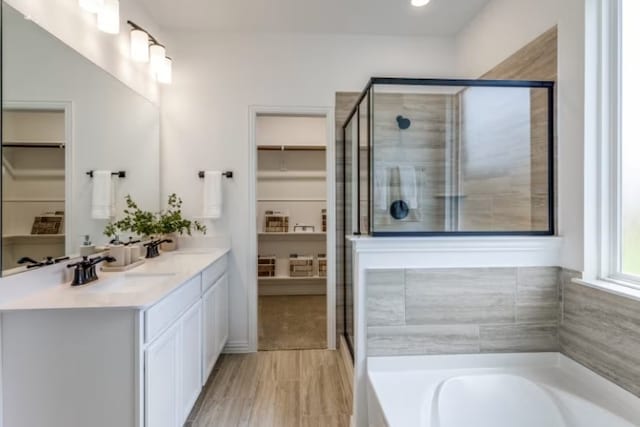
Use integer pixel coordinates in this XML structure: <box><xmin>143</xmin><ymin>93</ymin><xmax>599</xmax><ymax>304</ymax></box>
<box><xmin>583</xmin><ymin>0</ymin><xmax>640</xmax><ymax>288</ymax></box>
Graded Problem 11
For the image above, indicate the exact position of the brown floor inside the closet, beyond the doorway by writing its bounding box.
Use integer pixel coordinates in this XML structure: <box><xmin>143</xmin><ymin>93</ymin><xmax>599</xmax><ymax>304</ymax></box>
<box><xmin>258</xmin><ymin>295</ymin><xmax>327</xmax><ymax>350</ymax></box>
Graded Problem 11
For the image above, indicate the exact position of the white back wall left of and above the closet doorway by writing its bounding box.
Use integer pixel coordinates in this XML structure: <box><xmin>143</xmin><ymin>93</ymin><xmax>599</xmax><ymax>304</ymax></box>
<box><xmin>161</xmin><ymin>32</ymin><xmax>455</xmax><ymax>349</ymax></box>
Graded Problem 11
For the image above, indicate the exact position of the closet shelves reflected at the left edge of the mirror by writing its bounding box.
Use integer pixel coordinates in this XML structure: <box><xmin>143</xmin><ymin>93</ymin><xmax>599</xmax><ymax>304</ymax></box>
<box><xmin>2</xmin><ymin>103</ymin><xmax>66</xmax><ymax>270</ymax></box>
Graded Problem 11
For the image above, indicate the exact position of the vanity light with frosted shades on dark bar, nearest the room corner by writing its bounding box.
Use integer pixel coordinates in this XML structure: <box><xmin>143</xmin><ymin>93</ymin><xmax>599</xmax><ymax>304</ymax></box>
<box><xmin>127</xmin><ymin>21</ymin><xmax>173</xmax><ymax>84</ymax></box>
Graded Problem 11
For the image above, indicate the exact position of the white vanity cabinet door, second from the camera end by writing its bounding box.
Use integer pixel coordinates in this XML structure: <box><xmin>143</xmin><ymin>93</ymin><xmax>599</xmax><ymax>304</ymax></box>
<box><xmin>178</xmin><ymin>301</ymin><xmax>202</xmax><ymax>426</ymax></box>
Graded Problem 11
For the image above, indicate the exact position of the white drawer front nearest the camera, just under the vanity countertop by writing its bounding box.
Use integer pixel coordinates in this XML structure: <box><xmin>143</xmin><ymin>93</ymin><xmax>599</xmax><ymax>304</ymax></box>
<box><xmin>144</xmin><ymin>274</ymin><xmax>201</xmax><ymax>342</ymax></box>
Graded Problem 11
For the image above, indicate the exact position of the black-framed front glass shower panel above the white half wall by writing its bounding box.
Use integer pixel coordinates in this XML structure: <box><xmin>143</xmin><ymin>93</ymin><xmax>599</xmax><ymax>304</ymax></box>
<box><xmin>346</xmin><ymin>78</ymin><xmax>554</xmax><ymax>236</ymax></box>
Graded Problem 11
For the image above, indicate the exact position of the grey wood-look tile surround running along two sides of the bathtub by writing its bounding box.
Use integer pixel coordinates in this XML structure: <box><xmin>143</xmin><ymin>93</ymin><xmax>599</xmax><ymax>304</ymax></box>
<box><xmin>366</xmin><ymin>267</ymin><xmax>640</xmax><ymax>402</ymax></box>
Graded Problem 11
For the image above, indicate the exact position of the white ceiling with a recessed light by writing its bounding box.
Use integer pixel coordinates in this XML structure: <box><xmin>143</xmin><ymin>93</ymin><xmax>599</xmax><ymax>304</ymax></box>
<box><xmin>141</xmin><ymin>0</ymin><xmax>489</xmax><ymax>36</ymax></box>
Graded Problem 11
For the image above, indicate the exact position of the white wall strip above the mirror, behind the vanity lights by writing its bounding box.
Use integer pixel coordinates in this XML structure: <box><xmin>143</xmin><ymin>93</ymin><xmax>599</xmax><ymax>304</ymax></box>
<box><xmin>5</xmin><ymin>0</ymin><xmax>161</xmax><ymax>103</ymax></box>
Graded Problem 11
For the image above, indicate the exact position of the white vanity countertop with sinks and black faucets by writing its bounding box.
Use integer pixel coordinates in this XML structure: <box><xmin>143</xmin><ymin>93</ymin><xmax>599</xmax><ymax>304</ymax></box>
<box><xmin>0</xmin><ymin>249</ymin><xmax>229</xmax><ymax>311</ymax></box>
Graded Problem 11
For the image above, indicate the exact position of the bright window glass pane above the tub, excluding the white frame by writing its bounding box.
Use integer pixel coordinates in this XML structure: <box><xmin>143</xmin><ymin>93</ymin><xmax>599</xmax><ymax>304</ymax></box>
<box><xmin>612</xmin><ymin>0</ymin><xmax>640</xmax><ymax>282</ymax></box>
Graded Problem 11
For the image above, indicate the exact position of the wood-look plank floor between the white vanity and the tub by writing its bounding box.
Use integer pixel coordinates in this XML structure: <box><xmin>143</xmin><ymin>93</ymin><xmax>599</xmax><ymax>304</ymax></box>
<box><xmin>185</xmin><ymin>350</ymin><xmax>352</xmax><ymax>427</ymax></box>
